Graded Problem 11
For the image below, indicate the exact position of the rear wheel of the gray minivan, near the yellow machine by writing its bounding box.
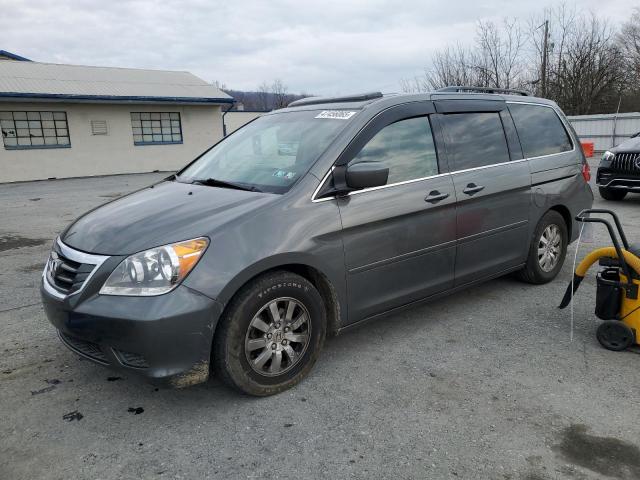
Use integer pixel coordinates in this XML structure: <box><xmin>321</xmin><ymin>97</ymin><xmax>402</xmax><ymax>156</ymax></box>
<box><xmin>518</xmin><ymin>210</ymin><xmax>569</xmax><ymax>285</ymax></box>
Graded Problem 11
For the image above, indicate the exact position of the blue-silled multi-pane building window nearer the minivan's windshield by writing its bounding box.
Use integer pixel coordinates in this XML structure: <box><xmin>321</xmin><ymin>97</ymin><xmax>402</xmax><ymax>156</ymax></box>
<box><xmin>131</xmin><ymin>112</ymin><xmax>182</xmax><ymax>145</ymax></box>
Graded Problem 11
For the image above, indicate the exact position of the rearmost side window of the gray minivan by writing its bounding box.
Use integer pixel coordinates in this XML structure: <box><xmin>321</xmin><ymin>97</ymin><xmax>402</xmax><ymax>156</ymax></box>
<box><xmin>509</xmin><ymin>103</ymin><xmax>573</xmax><ymax>158</ymax></box>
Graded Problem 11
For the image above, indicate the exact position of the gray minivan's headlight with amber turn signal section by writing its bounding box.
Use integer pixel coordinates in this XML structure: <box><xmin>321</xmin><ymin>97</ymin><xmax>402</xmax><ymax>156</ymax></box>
<box><xmin>100</xmin><ymin>238</ymin><xmax>209</xmax><ymax>297</ymax></box>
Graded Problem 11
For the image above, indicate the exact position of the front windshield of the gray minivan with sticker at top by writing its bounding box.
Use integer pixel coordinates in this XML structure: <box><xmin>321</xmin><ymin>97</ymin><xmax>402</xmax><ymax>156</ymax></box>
<box><xmin>178</xmin><ymin>111</ymin><xmax>353</xmax><ymax>193</ymax></box>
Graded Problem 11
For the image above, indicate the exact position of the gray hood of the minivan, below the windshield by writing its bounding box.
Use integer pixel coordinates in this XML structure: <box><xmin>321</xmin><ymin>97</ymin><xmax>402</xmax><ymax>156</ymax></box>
<box><xmin>60</xmin><ymin>181</ymin><xmax>279</xmax><ymax>255</ymax></box>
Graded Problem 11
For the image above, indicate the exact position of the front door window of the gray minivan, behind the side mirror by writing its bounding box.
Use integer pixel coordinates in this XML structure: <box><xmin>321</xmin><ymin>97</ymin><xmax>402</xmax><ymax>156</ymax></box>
<box><xmin>351</xmin><ymin>117</ymin><xmax>438</xmax><ymax>184</ymax></box>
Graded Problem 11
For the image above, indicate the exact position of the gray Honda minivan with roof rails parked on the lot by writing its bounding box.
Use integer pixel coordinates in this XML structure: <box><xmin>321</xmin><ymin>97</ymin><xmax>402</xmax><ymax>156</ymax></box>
<box><xmin>41</xmin><ymin>87</ymin><xmax>593</xmax><ymax>395</ymax></box>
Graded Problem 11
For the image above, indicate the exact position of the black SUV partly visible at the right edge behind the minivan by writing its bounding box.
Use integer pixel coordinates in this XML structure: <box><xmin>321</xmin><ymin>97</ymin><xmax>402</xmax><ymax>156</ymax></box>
<box><xmin>596</xmin><ymin>132</ymin><xmax>640</xmax><ymax>200</ymax></box>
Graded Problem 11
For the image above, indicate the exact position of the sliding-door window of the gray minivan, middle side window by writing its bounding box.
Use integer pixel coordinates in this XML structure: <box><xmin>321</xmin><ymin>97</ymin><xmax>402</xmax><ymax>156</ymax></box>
<box><xmin>442</xmin><ymin>113</ymin><xmax>509</xmax><ymax>170</ymax></box>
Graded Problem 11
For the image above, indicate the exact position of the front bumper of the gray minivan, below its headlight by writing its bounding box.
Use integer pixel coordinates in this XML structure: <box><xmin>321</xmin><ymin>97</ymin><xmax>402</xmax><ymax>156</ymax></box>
<box><xmin>40</xmin><ymin>278</ymin><xmax>222</xmax><ymax>387</ymax></box>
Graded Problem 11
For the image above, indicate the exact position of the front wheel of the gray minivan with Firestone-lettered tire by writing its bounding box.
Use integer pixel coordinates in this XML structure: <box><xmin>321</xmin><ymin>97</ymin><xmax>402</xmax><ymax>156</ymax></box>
<box><xmin>212</xmin><ymin>271</ymin><xmax>327</xmax><ymax>397</ymax></box>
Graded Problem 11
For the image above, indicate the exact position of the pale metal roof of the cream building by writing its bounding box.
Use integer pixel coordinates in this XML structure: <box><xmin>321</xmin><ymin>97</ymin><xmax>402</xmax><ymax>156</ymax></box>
<box><xmin>0</xmin><ymin>61</ymin><xmax>233</xmax><ymax>103</ymax></box>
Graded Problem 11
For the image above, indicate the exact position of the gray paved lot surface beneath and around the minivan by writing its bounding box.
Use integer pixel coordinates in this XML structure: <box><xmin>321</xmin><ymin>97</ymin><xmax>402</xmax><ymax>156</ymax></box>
<box><xmin>0</xmin><ymin>163</ymin><xmax>640</xmax><ymax>480</ymax></box>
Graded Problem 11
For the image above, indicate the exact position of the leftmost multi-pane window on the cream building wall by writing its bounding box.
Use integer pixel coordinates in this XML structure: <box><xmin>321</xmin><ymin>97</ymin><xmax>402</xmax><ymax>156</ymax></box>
<box><xmin>0</xmin><ymin>111</ymin><xmax>71</xmax><ymax>150</ymax></box>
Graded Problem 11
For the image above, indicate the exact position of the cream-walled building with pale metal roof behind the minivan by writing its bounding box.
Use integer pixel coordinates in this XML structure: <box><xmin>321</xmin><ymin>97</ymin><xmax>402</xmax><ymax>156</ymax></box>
<box><xmin>0</xmin><ymin>50</ymin><xmax>233</xmax><ymax>183</ymax></box>
